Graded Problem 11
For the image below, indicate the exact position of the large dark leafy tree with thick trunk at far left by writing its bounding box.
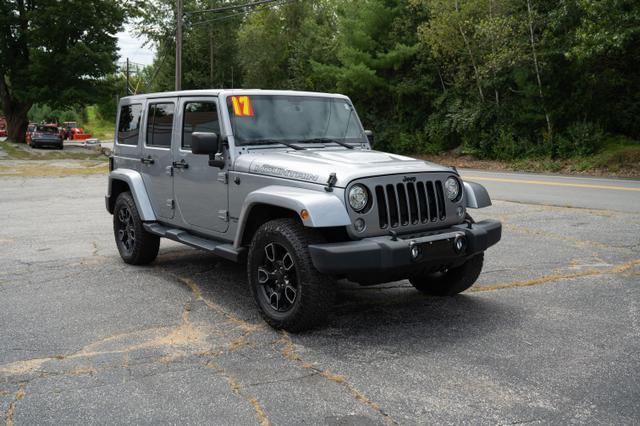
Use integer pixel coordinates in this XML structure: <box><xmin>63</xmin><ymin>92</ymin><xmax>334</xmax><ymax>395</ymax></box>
<box><xmin>0</xmin><ymin>0</ymin><xmax>125</xmax><ymax>141</ymax></box>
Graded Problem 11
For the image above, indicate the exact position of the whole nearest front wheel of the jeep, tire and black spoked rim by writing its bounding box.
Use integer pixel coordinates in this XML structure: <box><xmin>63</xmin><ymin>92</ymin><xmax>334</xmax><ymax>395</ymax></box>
<box><xmin>247</xmin><ymin>219</ymin><xmax>335</xmax><ymax>332</ymax></box>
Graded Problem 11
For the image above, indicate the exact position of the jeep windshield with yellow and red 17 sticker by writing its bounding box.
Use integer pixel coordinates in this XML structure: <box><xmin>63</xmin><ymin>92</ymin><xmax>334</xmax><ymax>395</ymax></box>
<box><xmin>227</xmin><ymin>95</ymin><xmax>366</xmax><ymax>145</ymax></box>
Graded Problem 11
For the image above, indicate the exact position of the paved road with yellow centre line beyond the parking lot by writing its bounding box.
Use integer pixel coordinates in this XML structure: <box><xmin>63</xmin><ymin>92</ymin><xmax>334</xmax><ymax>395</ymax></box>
<box><xmin>460</xmin><ymin>170</ymin><xmax>640</xmax><ymax>213</ymax></box>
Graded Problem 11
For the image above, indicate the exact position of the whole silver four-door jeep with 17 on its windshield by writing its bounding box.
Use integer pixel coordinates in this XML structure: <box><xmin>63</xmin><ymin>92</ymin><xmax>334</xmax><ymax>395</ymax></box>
<box><xmin>106</xmin><ymin>90</ymin><xmax>501</xmax><ymax>331</ymax></box>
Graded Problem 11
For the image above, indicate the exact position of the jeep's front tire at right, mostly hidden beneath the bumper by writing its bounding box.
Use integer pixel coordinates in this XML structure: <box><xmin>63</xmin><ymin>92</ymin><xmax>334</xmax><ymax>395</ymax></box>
<box><xmin>409</xmin><ymin>253</ymin><xmax>484</xmax><ymax>296</ymax></box>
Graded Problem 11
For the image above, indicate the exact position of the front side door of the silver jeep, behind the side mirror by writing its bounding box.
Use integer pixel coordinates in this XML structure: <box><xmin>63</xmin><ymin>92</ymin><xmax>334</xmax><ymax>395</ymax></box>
<box><xmin>173</xmin><ymin>97</ymin><xmax>229</xmax><ymax>236</ymax></box>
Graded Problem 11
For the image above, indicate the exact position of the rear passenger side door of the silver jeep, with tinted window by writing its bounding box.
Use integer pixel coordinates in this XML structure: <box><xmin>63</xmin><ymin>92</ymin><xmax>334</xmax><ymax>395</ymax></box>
<box><xmin>140</xmin><ymin>99</ymin><xmax>176</xmax><ymax>219</ymax></box>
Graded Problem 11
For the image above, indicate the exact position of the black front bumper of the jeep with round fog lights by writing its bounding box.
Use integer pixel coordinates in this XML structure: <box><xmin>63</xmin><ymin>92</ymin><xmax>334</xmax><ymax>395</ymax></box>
<box><xmin>309</xmin><ymin>220</ymin><xmax>502</xmax><ymax>275</ymax></box>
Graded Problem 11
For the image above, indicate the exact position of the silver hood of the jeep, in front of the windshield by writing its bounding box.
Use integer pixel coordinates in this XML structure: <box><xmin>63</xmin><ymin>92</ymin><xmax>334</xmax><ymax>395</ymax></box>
<box><xmin>234</xmin><ymin>148</ymin><xmax>451</xmax><ymax>188</ymax></box>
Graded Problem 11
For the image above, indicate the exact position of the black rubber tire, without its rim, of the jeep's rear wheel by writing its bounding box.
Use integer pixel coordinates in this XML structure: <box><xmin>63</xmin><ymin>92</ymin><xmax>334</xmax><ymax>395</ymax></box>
<box><xmin>113</xmin><ymin>191</ymin><xmax>160</xmax><ymax>265</ymax></box>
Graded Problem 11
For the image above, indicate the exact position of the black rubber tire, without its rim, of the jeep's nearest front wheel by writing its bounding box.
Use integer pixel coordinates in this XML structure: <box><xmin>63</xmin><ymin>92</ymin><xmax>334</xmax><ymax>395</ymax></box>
<box><xmin>247</xmin><ymin>219</ymin><xmax>335</xmax><ymax>332</ymax></box>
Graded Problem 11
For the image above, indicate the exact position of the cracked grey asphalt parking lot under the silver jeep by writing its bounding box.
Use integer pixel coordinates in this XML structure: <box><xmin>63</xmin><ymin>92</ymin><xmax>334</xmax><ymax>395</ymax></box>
<box><xmin>0</xmin><ymin>176</ymin><xmax>640</xmax><ymax>425</ymax></box>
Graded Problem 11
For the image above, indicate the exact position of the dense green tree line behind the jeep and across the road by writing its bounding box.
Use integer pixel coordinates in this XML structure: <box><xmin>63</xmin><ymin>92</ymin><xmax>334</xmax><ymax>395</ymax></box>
<box><xmin>141</xmin><ymin>0</ymin><xmax>640</xmax><ymax>159</ymax></box>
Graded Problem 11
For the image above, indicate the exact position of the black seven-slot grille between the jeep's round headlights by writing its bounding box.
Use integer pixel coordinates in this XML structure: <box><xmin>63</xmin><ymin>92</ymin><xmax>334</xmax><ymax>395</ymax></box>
<box><xmin>375</xmin><ymin>180</ymin><xmax>447</xmax><ymax>229</ymax></box>
